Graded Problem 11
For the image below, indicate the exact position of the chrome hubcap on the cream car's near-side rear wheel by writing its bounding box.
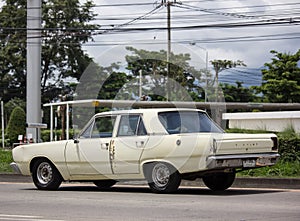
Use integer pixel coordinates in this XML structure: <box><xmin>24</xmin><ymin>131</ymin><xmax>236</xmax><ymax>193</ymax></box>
<box><xmin>152</xmin><ymin>163</ymin><xmax>170</xmax><ymax>187</ymax></box>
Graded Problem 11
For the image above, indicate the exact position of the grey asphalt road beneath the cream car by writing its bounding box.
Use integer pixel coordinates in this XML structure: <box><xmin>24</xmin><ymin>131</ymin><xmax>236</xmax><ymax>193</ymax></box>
<box><xmin>0</xmin><ymin>182</ymin><xmax>300</xmax><ymax>221</ymax></box>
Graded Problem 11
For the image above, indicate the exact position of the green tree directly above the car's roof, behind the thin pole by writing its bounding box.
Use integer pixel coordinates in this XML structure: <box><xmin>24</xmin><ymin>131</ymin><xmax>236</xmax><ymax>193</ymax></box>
<box><xmin>126</xmin><ymin>47</ymin><xmax>203</xmax><ymax>100</ymax></box>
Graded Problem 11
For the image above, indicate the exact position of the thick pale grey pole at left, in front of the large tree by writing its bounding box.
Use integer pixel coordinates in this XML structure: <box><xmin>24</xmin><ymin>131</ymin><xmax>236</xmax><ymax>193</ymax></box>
<box><xmin>26</xmin><ymin>0</ymin><xmax>42</xmax><ymax>142</ymax></box>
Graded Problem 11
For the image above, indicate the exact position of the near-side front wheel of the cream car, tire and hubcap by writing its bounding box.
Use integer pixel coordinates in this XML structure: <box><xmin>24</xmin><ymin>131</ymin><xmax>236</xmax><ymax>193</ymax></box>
<box><xmin>32</xmin><ymin>159</ymin><xmax>63</xmax><ymax>190</ymax></box>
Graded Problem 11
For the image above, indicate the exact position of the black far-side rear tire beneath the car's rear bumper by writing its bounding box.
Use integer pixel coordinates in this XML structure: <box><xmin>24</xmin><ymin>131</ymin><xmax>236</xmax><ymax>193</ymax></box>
<box><xmin>203</xmin><ymin>172</ymin><xmax>235</xmax><ymax>191</ymax></box>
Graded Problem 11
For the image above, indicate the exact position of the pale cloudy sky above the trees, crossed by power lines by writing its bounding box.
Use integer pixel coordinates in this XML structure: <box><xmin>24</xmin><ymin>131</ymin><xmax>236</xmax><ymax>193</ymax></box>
<box><xmin>82</xmin><ymin>0</ymin><xmax>300</xmax><ymax>84</ymax></box>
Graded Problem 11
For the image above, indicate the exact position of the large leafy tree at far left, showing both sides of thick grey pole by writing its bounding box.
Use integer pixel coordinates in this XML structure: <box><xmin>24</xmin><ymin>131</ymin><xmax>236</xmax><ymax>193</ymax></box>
<box><xmin>0</xmin><ymin>0</ymin><xmax>99</xmax><ymax>101</ymax></box>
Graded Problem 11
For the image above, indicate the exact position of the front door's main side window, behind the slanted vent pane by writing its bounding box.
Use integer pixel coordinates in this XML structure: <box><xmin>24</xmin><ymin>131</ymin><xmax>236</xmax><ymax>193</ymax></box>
<box><xmin>91</xmin><ymin>116</ymin><xmax>116</xmax><ymax>138</ymax></box>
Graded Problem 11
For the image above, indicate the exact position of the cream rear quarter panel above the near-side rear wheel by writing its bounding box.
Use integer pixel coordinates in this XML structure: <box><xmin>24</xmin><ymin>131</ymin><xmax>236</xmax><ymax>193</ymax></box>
<box><xmin>141</xmin><ymin>134</ymin><xmax>211</xmax><ymax>173</ymax></box>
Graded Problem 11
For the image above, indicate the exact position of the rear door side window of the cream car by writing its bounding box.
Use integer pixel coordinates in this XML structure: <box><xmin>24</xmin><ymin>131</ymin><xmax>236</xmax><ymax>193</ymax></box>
<box><xmin>118</xmin><ymin>115</ymin><xmax>147</xmax><ymax>136</ymax></box>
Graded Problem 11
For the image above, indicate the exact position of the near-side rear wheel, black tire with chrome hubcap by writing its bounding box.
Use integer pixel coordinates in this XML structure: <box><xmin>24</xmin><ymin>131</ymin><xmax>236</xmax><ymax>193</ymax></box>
<box><xmin>144</xmin><ymin>162</ymin><xmax>181</xmax><ymax>193</ymax></box>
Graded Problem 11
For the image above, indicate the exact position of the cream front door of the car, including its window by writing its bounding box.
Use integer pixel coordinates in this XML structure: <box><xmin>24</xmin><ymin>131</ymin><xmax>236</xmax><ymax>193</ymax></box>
<box><xmin>66</xmin><ymin>116</ymin><xmax>115</xmax><ymax>176</ymax></box>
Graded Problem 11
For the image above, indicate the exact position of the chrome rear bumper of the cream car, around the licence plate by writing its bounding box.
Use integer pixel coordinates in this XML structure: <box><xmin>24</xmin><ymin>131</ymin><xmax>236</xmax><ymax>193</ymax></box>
<box><xmin>206</xmin><ymin>153</ymin><xmax>280</xmax><ymax>169</ymax></box>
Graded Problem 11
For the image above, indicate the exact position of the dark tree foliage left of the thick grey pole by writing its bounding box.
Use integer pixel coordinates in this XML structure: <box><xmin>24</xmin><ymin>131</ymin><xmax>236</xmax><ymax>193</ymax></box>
<box><xmin>0</xmin><ymin>0</ymin><xmax>26</xmax><ymax>102</ymax></box>
